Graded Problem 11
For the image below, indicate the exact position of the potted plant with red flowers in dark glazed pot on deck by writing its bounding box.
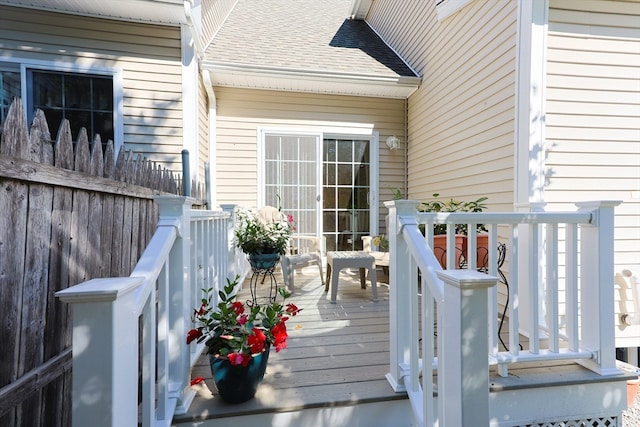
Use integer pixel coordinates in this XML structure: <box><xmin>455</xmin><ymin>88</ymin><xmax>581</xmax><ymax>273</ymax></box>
<box><xmin>187</xmin><ymin>277</ymin><xmax>301</xmax><ymax>403</ymax></box>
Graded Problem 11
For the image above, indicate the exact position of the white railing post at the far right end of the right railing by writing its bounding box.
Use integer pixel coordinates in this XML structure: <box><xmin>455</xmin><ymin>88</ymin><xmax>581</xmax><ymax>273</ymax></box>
<box><xmin>576</xmin><ymin>201</ymin><xmax>621</xmax><ymax>375</ymax></box>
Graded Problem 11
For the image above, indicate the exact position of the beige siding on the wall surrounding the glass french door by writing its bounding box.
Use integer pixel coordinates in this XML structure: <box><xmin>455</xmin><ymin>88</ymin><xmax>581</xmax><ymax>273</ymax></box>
<box><xmin>214</xmin><ymin>87</ymin><xmax>406</xmax><ymax>218</ymax></box>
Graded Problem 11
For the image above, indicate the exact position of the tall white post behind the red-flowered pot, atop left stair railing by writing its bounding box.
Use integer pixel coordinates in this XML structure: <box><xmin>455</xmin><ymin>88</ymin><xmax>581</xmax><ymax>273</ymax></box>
<box><xmin>154</xmin><ymin>196</ymin><xmax>195</xmax><ymax>413</ymax></box>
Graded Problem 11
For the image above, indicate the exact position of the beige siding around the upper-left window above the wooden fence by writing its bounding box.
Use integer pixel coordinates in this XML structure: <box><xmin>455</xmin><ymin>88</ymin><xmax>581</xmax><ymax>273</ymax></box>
<box><xmin>0</xmin><ymin>6</ymin><xmax>182</xmax><ymax>171</ymax></box>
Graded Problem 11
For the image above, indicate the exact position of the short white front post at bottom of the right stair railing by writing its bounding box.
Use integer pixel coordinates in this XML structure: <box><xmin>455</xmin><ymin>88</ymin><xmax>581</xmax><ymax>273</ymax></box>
<box><xmin>437</xmin><ymin>270</ymin><xmax>498</xmax><ymax>427</ymax></box>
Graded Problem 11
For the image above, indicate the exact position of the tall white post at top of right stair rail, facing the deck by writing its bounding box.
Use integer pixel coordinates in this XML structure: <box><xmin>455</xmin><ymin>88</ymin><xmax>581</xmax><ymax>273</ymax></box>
<box><xmin>385</xmin><ymin>200</ymin><xmax>419</xmax><ymax>392</ymax></box>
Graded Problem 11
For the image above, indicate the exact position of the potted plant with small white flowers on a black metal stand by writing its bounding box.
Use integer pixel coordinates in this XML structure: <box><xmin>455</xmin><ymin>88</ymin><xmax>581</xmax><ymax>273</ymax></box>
<box><xmin>234</xmin><ymin>208</ymin><xmax>295</xmax><ymax>268</ymax></box>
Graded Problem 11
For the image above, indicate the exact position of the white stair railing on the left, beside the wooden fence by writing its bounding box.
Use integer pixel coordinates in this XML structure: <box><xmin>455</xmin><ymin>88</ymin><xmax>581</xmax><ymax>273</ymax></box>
<box><xmin>56</xmin><ymin>196</ymin><xmax>246</xmax><ymax>427</ymax></box>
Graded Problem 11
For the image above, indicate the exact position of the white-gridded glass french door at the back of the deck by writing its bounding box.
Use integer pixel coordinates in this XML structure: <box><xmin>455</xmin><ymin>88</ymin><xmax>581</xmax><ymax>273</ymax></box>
<box><xmin>261</xmin><ymin>133</ymin><xmax>377</xmax><ymax>251</ymax></box>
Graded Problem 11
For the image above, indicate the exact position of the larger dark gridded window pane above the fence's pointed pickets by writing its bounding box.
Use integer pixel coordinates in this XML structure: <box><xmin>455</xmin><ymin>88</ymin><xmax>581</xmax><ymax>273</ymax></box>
<box><xmin>27</xmin><ymin>70</ymin><xmax>114</xmax><ymax>144</ymax></box>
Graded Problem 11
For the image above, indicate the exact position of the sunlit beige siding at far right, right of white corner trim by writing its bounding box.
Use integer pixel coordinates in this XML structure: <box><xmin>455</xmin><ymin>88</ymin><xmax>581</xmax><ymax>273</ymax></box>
<box><xmin>545</xmin><ymin>0</ymin><xmax>640</xmax><ymax>271</ymax></box>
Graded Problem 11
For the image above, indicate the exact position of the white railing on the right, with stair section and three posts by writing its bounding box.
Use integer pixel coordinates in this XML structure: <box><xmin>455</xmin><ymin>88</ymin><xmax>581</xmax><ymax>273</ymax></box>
<box><xmin>386</xmin><ymin>200</ymin><xmax>619</xmax><ymax>427</ymax></box>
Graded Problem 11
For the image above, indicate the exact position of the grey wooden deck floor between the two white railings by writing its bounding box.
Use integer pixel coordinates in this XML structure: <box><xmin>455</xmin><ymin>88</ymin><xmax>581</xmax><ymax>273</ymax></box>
<box><xmin>174</xmin><ymin>267</ymin><xmax>400</xmax><ymax>423</ymax></box>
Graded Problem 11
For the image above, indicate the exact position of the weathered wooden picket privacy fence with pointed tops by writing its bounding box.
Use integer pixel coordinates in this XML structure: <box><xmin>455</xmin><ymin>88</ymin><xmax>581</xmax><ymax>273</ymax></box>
<box><xmin>0</xmin><ymin>100</ymin><xmax>178</xmax><ymax>426</ymax></box>
